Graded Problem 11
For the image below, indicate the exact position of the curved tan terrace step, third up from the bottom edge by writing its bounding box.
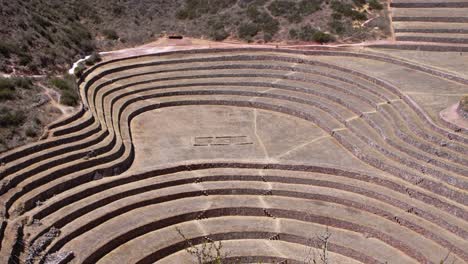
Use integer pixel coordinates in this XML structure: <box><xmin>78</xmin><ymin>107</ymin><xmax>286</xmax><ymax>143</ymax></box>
<box><xmin>54</xmin><ymin>195</ymin><xmax>460</xmax><ymax>263</ymax></box>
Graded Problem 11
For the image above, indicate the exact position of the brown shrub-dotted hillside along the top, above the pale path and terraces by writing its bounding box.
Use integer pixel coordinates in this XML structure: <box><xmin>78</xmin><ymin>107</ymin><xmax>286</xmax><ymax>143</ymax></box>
<box><xmin>0</xmin><ymin>0</ymin><xmax>389</xmax><ymax>74</ymax></box>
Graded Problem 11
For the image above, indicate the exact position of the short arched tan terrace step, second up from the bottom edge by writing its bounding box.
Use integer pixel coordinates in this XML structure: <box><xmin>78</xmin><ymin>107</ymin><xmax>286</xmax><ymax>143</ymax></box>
<box><xmin>98</xmin><ymin>216</ymin><xmax>414</xmax><ymax>263</ymax></box>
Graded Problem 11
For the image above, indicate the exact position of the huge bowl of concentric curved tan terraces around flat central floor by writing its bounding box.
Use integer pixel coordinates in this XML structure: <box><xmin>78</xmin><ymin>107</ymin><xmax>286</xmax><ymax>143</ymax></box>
<box><xmin>0</xmin><ymin>32</ymin><xmax>468</xmax><ymax>263</ymax></box>
